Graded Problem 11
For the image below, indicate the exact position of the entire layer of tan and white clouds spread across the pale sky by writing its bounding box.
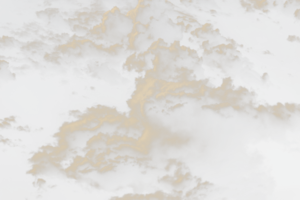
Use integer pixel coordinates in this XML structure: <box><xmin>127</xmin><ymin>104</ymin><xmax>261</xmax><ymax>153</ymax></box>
<box><xmin>0</xmin><ymin>0</ymin><xmax>300</xmax><ymax>200</ymax></box>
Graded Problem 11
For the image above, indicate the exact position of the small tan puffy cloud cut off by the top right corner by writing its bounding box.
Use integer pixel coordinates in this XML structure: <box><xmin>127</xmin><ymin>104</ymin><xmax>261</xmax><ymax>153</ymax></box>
<box><xmin>240</xmin><ymin>0</ymin><xmax>300</xmax><ymax>20</ymax></box>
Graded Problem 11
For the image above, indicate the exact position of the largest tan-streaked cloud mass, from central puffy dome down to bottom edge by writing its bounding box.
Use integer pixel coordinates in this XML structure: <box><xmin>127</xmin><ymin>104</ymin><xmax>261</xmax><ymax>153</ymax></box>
<box><xmin>27</xmin><ymin>39</ymin><xmax>300</xmax><ymax>200</ymax></box>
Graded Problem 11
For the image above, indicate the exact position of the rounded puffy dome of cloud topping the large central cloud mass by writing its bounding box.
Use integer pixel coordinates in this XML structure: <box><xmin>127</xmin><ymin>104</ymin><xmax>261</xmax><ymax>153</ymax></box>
<box><xmin>123</xmin><ymin>39</ymin><xmax>204</xmax><ymax>80</ymax></box>
